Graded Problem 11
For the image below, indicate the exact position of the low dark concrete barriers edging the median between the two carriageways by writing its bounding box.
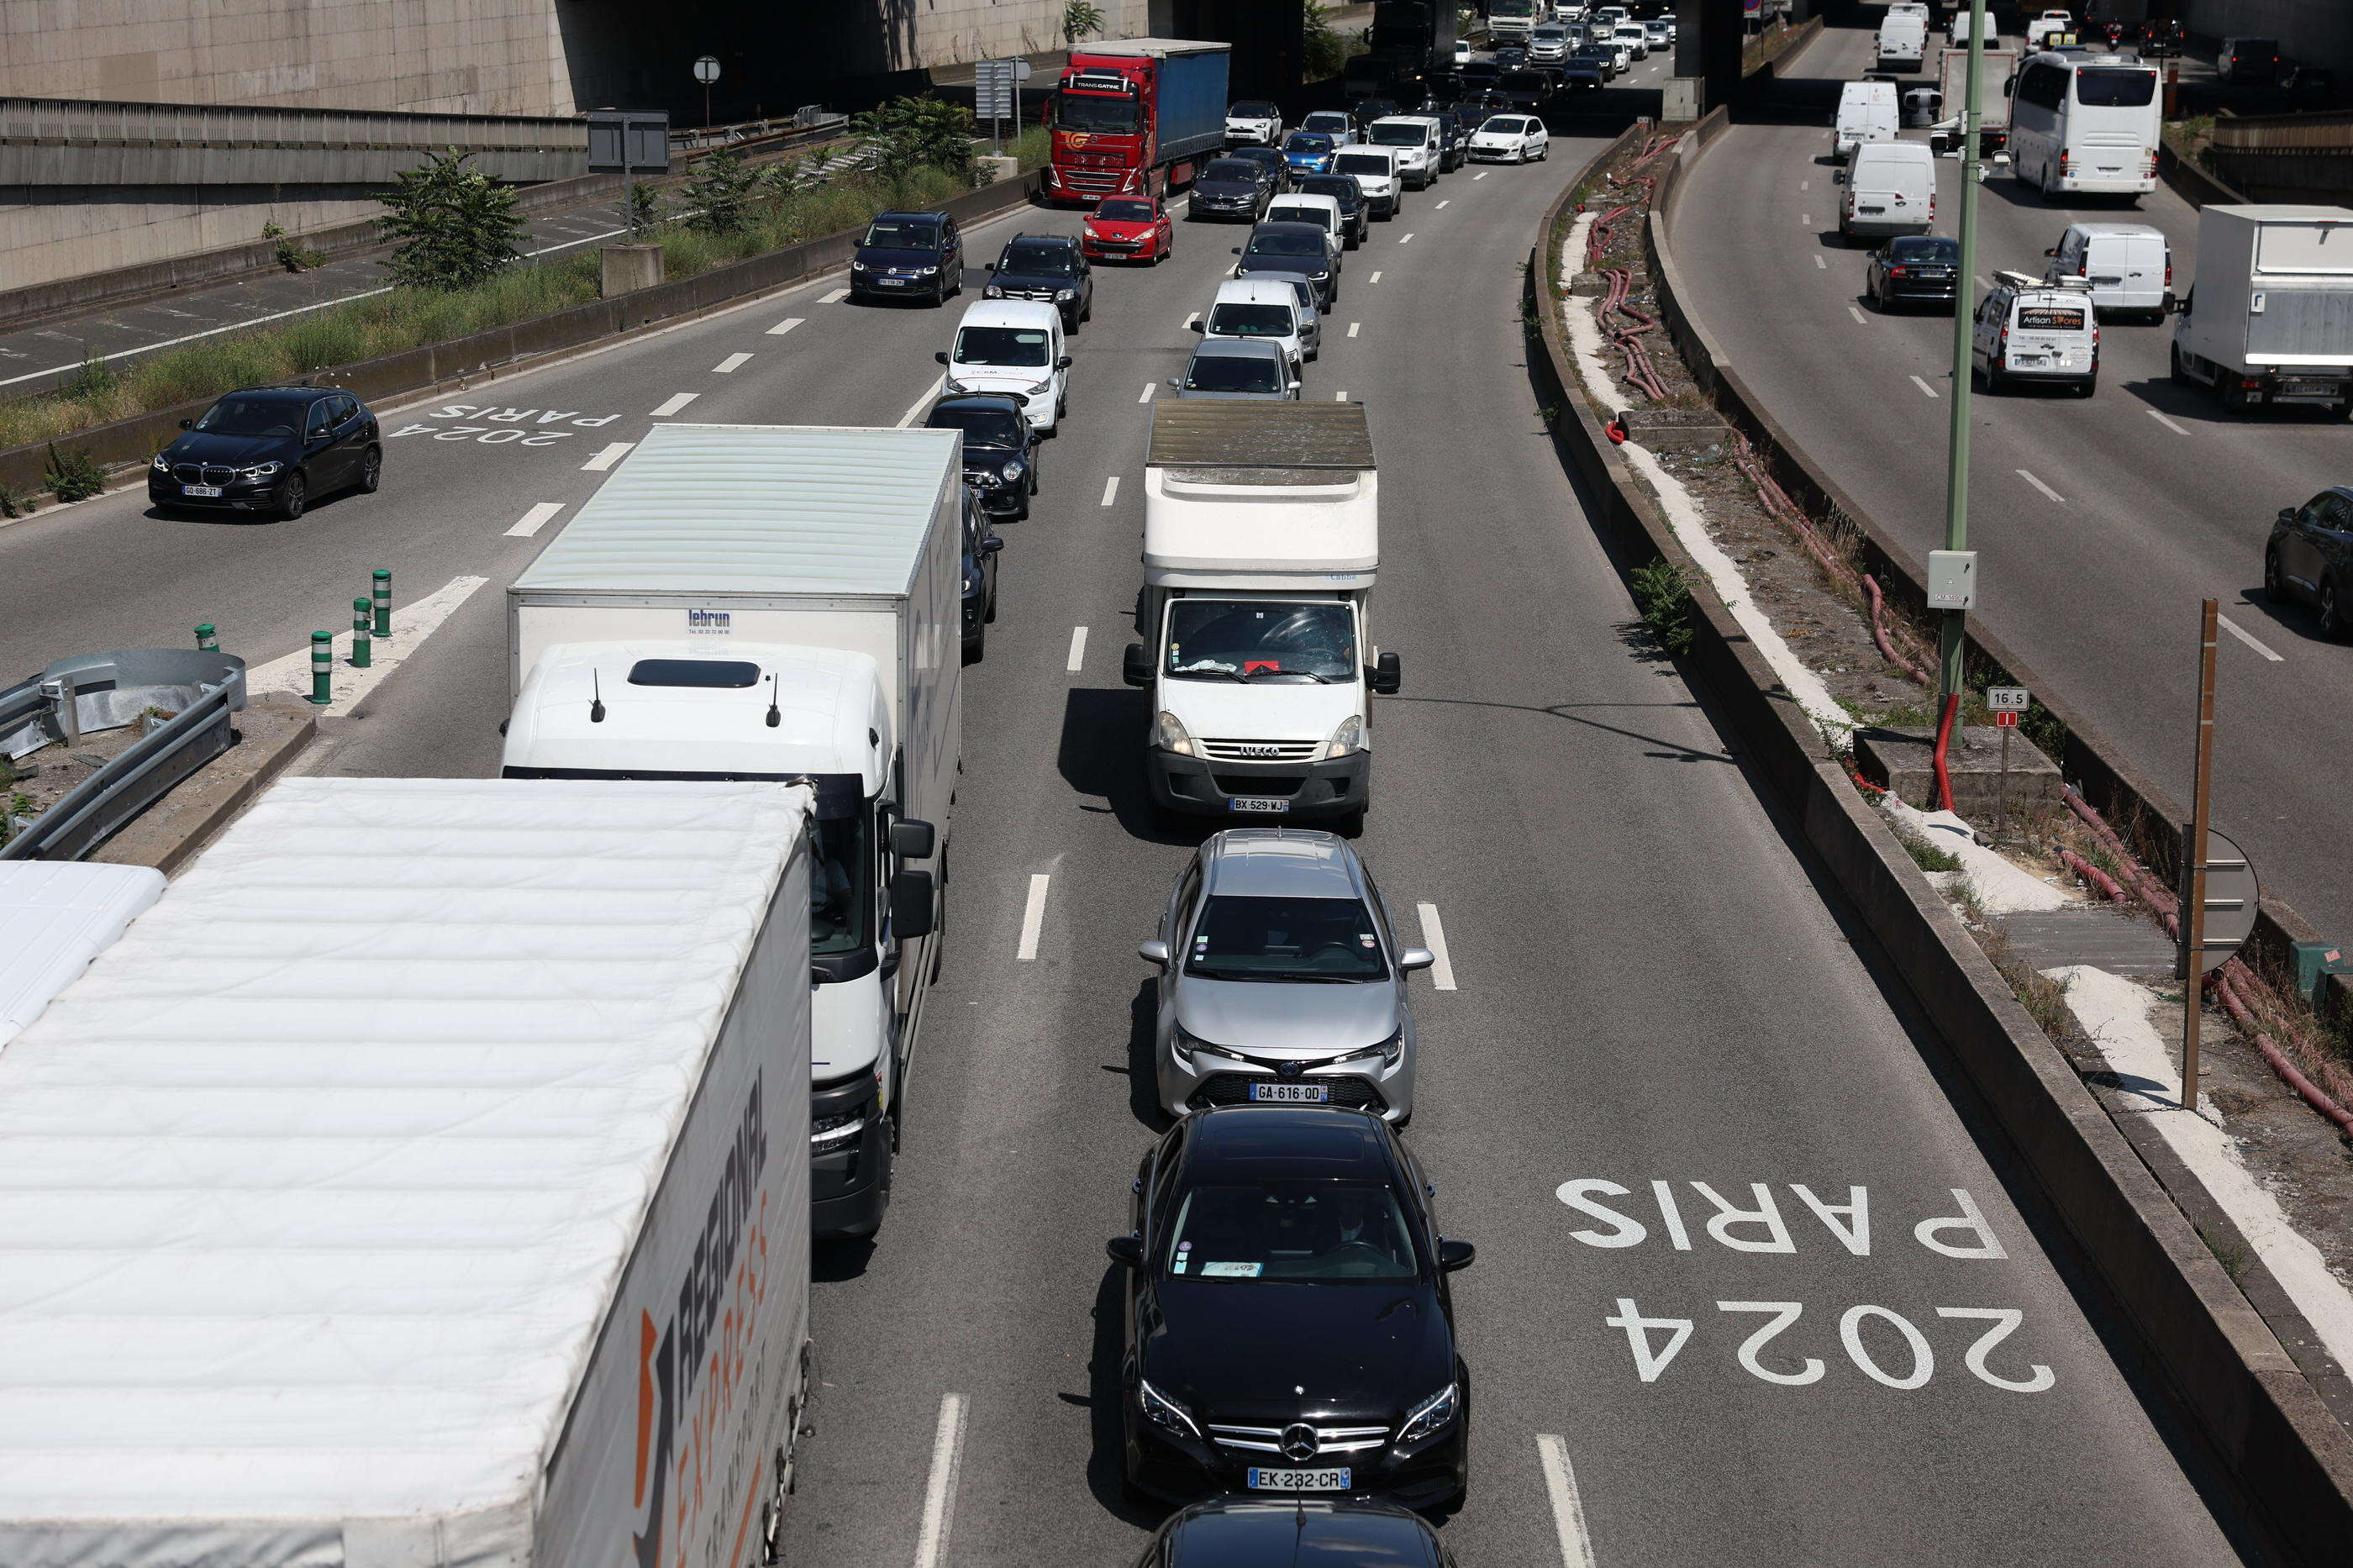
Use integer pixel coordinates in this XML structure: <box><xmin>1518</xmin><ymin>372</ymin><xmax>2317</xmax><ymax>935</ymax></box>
<box><xmin>1524</xmin><ymin>115</ymin><xmax>2353</xmax><ymax>1563</ymax></box>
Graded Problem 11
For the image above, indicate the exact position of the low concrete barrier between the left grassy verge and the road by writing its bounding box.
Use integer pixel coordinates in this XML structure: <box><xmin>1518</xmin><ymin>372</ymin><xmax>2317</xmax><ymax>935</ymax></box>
<box><xmin>0</xmin><ymin>174</ymin><xmax>1038</xmax><ymax>506</ymax></box>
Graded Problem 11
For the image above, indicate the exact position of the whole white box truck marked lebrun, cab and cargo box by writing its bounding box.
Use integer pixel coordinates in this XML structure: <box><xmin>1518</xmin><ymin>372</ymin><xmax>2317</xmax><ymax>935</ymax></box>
<box><xmin>501</xmin><ymin>424</ymin><xmax>965</xmax><ymax>1239</ymax></box>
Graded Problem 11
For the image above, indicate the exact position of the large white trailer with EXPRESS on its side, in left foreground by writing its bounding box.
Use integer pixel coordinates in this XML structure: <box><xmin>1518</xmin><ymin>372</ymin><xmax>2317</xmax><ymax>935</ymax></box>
<box><xmin>0</xmin><ymin>779</ymin><xmax>809</xmax><ymax>1568</ymax></box>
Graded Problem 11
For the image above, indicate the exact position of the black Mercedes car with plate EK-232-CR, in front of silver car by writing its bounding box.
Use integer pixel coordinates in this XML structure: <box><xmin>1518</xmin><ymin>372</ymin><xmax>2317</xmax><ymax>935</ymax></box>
<box><xmin>1108</xmin><ymin>1107</ymin><xmax>1473</xmax><ymax>1509</ymax></box>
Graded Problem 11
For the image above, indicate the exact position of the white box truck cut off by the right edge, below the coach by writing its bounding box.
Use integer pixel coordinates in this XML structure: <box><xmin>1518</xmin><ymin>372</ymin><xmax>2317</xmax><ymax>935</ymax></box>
<box><xmin>2171</xmin><ymin>205</ymin><xmax>2353</xmax><ymax>419</ymax></box>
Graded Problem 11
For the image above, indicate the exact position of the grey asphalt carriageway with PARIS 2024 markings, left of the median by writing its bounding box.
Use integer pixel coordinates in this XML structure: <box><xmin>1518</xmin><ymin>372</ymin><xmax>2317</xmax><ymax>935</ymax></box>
<box><xmin>0</xmin><ymin>82</ymin><xmax>2240</xmax><ymax>1568</ymax></box>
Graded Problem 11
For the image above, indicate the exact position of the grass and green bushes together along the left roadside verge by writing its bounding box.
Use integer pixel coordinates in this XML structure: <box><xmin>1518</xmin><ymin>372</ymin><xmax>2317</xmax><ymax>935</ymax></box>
<box><xmin>0</xmin><ymin>99</ymin><xmax>1012</xmax><ymax>454</ymax></box>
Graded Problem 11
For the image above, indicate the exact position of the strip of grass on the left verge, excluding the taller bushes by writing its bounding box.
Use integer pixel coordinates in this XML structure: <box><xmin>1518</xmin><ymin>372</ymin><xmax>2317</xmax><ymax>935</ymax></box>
<box><xmin>0</xmin><ymin>166</ymin><xmax>969</xmax><ymax>459</ymax></box>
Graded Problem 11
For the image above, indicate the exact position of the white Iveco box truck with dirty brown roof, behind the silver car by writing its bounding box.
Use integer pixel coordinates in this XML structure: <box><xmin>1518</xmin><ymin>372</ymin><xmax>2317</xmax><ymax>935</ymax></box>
<box><xmin>1123</xmin><ymin>403</ymin><xmax>1403</xmax><ymax>831</ymax></box>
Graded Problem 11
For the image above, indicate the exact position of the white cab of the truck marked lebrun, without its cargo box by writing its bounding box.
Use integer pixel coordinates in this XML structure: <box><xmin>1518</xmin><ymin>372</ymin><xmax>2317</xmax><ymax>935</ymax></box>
<box><xmin>499</xmin><ymin>638</ymin><xmax>934</xmax><ymax>1236</ymax></box>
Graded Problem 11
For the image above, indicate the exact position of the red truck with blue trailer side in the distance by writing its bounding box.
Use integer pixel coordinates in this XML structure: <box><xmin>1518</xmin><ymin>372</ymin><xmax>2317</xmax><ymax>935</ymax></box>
<box><xmin>1045</xmin><ymin>38</ymin><xmax>1233</xmax><ymax>208</ymax></box>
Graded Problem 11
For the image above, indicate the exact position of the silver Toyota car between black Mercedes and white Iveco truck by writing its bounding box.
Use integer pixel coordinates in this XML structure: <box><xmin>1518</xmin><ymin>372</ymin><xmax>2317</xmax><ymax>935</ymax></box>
<box><xmin>1136</xmin><ymin>829</ymin><xmax>1433</xmax><ymax>1123</ymax></box>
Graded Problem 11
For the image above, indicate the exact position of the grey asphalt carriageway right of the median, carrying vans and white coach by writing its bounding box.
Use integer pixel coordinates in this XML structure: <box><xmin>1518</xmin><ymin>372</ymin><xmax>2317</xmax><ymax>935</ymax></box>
<box><xmin>1671</xmin><ymin>15</ymin><xmax>2353</xmax><ymax>933</ymax></box>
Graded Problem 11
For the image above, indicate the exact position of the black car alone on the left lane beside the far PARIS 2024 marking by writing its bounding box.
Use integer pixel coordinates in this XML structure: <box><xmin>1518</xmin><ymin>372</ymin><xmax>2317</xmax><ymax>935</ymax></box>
<box><xmin>148</xmin><ymin>386</ymin><xmax>383</xmax><ymax>523</ymax></box>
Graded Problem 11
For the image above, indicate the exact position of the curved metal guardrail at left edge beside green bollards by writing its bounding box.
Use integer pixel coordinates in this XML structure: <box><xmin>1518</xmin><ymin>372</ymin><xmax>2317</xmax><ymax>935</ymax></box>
<box><xmin>0</xmin><ymin>647</ymin><xmax>245</xmax><ymax>860</ymax></box>
